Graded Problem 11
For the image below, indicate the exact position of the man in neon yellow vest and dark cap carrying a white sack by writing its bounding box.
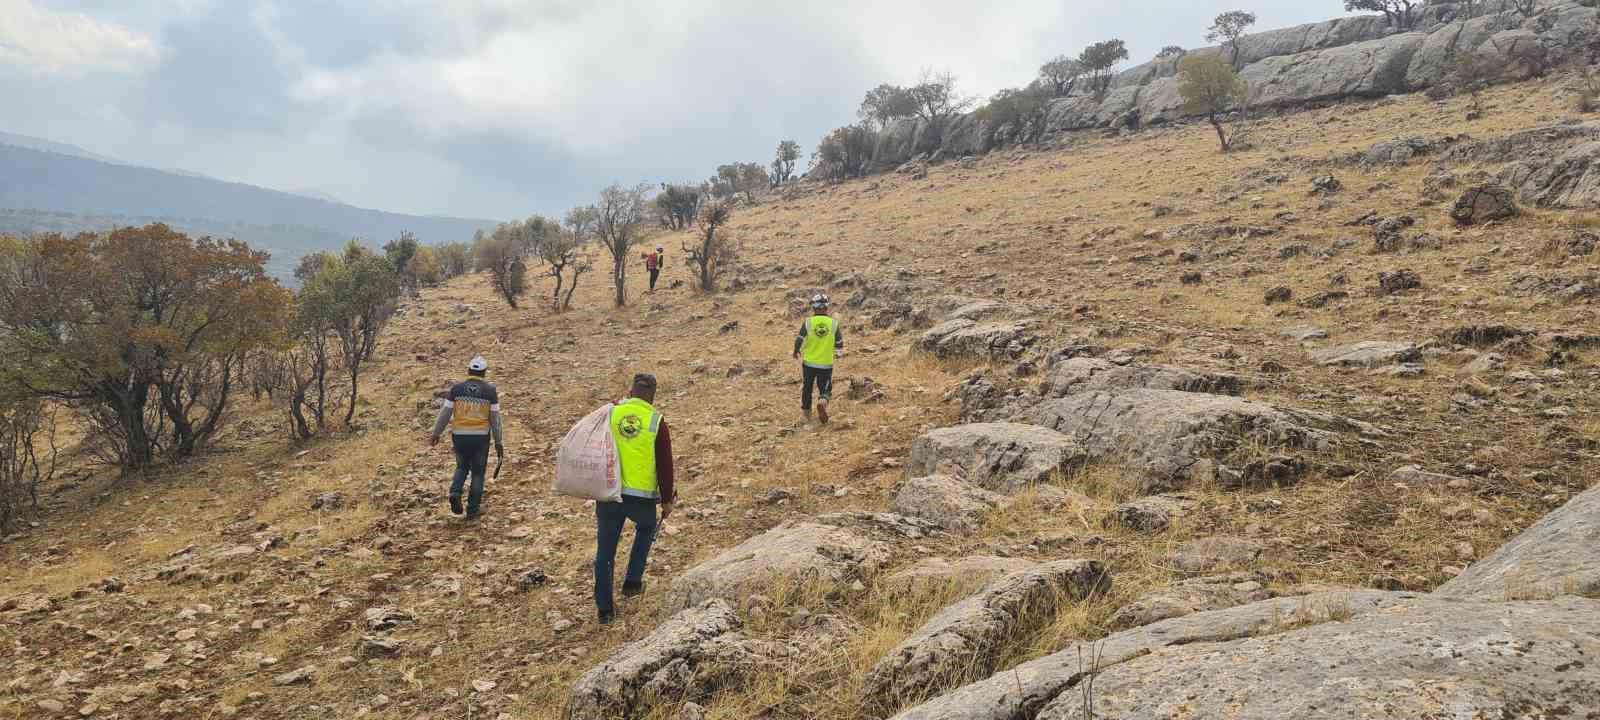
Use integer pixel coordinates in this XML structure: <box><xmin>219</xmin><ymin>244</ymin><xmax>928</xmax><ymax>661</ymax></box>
<box><xmin>595</xmin><ymin>373</ymin><xmax>677</xmax><ymax>624</ymax></box>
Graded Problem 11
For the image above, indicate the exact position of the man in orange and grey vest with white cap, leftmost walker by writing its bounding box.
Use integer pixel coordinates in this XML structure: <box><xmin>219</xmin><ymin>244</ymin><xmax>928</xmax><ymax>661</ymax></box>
<box><xmin>427</xmin><ymin>355</ymin><xmax>506</xmax><ymax>522</ymax></box>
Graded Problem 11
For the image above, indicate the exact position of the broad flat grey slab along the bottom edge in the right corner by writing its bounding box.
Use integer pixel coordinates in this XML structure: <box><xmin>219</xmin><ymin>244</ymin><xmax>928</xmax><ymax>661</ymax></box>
<box><xmin>1034</xmin><ymin>598</ymin><xmax>1600</xmax><ymax>720</ymax></box>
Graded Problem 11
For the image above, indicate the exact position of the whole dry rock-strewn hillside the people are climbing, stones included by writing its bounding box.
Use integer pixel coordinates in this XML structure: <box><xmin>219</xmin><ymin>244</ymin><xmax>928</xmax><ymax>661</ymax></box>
<box><xmin>0</xmin><ymin>50</ymin><xmax>1600</xmax><ymax>720</ymax></box>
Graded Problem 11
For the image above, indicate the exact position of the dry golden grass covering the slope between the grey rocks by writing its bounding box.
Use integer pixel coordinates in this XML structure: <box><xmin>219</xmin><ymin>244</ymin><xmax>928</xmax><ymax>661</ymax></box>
<box><xmin>0</xmin><ymin>73</ymin><xmax>1600</xmax><ymax>720</ymax></box>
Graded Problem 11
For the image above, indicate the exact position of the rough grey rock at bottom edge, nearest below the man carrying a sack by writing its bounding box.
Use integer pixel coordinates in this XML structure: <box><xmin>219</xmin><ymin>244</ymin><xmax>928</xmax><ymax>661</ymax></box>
<box><xmin>566</xmin><ymin>600</ymin><xmax>782</xmax><ymax>720</ymax></box>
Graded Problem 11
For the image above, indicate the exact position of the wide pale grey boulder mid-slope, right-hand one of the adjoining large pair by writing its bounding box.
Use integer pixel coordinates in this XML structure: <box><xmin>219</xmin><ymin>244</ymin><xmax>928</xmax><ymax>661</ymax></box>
<box><xmin>1018</xmin><ymin>389</ymin><xmax>1358</xmax><ymax>493</ymax></box>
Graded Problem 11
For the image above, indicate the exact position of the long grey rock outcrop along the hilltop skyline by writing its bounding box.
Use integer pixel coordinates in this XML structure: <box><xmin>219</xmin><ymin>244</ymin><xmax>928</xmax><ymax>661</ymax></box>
<box><xmin>874</xmin><ymin>0</ymin><xmax>1600</xmax><ymax>168</ymax></box>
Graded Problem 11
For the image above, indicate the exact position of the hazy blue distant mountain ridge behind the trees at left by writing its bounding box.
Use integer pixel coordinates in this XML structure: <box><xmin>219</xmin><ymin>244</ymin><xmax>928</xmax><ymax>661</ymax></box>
<box><xmin>0</xmin><ymin>134</ymin><xmax>498</xmax><ymax>253</ymax></box>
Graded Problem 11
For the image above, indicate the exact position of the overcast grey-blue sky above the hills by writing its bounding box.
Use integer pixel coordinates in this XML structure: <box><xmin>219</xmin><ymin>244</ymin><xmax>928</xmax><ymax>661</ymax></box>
<box><xmin>0</xmin><ymin>0</ymin><xmax>1363</xmax><ymax>219</ymax></box>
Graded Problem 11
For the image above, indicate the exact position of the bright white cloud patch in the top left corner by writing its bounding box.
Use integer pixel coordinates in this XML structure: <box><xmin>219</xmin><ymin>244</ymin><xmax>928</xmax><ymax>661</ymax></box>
<box><xmin>0</xmin><ymin>0</ymin><xmax>160</xmax><ymax>75</ymax></box>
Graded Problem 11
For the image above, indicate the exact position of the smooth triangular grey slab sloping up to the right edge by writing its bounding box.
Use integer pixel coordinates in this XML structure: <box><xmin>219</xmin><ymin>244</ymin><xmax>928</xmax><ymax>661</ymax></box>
<box><xmin>1434</xmin><ymin>488</ymin><xmax>1600</xmax><ymax>600</ymax></box>
